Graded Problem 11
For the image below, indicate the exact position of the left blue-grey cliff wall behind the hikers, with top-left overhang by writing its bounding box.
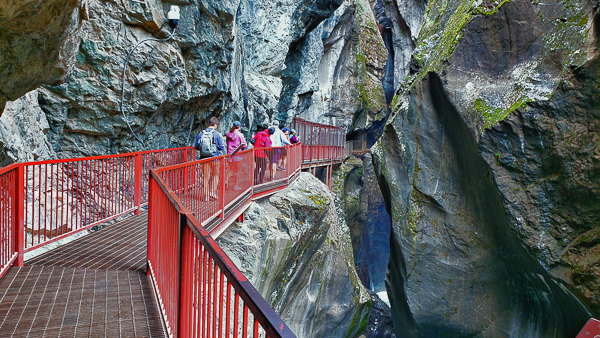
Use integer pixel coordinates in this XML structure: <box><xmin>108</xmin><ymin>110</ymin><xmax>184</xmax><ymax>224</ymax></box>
<box><xmin>0</xmin><ymin>0</ymin><xmax>388</xmax><ymax>158</ymax></box>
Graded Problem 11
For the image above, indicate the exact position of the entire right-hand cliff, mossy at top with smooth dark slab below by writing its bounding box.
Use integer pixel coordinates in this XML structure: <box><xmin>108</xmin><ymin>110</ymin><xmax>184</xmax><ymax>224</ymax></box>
<box><xmin>373</xmin><ymin>1</ymin><xmax>598</xmax><ymax>337</ymax></box>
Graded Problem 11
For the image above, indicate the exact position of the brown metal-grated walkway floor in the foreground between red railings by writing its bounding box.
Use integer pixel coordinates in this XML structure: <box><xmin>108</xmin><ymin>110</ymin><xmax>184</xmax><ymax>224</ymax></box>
<box><xmin>0</xmin><ymin>213</ymin><xmax>165</xmax><ymax>337</ymax></box>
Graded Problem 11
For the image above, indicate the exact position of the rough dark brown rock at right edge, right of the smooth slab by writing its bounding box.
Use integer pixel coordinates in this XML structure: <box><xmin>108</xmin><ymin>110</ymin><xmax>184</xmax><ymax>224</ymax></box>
<box><xmin>480</xmin><ymin>59</ymin><xmax>600</xmax><ymax>310</ymax></box>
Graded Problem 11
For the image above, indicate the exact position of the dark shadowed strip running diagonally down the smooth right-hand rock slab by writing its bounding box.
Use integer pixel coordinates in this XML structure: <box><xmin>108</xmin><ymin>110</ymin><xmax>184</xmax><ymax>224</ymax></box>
<box><xmin>429</xmin><ymin>73</ymin><xmax>591</xmax><ymax>337</ymax></box>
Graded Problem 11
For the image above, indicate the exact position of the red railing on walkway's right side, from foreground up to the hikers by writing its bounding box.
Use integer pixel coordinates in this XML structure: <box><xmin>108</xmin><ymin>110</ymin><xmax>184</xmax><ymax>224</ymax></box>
<box><xmin>148</xmin><ymin>144</ymin><xmax>302</xmax><ymax>337</ymax></box>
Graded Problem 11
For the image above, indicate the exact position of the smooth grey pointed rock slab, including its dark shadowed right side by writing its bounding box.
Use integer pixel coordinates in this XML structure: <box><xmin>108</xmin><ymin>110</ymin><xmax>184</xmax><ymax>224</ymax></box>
<box><xmin>374</xmin><ymin>73</ymin><xmax>592</xmax><ymax>337</ymax></box>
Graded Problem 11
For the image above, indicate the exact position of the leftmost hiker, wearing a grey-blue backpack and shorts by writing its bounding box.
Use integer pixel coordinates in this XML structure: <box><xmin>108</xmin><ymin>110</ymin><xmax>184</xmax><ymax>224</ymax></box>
<box><xmin>196</xmin><ymin>117</ymin><xmax>225</xmax><ymax>201</ymax></box>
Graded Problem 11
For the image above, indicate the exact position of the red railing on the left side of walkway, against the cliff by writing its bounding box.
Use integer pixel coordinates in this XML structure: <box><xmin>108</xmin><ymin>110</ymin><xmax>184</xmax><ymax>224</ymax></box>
<box><xmin>0</xmin><ymin>147</ymin><xmax>196</xmax><ymax>277</ymax></box>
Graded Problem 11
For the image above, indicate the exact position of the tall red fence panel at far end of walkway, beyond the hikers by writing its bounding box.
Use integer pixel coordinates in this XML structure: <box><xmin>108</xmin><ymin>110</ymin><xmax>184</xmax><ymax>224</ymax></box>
<box><xmin>292</xmin><ymin>118</ymin><xmax>346</xmax><ymax>165</ymax></box>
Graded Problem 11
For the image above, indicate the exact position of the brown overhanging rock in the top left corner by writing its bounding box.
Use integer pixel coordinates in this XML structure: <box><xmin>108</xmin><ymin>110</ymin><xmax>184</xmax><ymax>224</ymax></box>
<box><xmin>0</xmin><ymin>0</ymin><xmax>81</xmax><ymax>111</ymax></box>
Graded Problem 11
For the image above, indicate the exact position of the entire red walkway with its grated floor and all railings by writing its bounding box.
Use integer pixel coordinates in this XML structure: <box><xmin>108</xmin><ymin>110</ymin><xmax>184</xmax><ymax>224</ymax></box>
<box><xmin>0</xmin><ymin>120</ymin><xmax>345</xmax><ymax>337</ymax></box>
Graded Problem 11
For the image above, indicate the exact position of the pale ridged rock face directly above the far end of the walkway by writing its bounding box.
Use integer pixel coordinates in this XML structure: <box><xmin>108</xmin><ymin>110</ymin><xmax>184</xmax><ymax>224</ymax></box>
<box><xmin>280</xmin><ymin>0</ymin><xmax>388</xmax><ymax>130</ymax></box>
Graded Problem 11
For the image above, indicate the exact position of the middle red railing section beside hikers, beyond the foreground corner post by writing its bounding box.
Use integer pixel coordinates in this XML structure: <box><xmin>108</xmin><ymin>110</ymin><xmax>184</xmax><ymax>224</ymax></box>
<box><xmin>156</xmin><ymin>144</ymin><xmax>301</xmax><ymax>230</ymax></box>
